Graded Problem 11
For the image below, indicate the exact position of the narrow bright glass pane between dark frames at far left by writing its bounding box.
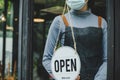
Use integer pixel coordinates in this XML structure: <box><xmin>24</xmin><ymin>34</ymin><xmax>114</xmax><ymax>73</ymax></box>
<box><xmin>5</xmin><ymin>1</ymin><xmax>13</xmax><ymax>76</ymax></box>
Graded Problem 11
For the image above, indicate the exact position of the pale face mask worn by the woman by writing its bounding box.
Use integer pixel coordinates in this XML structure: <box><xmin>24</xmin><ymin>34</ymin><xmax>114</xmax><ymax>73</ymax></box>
<box><xmin>66</xmin><ymin>0</ymin><xmax>87</xmax><ymax>10</ymax></box>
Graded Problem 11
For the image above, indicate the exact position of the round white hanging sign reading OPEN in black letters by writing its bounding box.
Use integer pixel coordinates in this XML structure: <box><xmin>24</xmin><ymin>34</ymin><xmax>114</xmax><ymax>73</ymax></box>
<box><xmin>51</xmin><ymin>46</ymin><xmax>81</xmax><ymax>80</ymax></box>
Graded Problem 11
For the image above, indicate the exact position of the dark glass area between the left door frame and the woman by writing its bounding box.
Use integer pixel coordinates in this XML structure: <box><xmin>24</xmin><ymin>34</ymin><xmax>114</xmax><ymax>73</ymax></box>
<box><xmin>33</xmin><ymin>0</ymin><xmax>64</xmax><ymax>80</ymax></box>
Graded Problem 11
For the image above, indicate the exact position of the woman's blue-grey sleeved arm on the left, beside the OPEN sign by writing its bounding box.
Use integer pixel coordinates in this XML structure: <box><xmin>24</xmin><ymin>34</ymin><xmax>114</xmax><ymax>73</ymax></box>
<box><xmin>42</xmin><ymin>17</ymin><xmax>60</xmax><ymax>75</ymax></box>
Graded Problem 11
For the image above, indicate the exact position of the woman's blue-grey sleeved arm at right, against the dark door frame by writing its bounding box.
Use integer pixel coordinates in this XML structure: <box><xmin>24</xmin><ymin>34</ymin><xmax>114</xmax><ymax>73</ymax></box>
<box><xmin>94</xmin><ymin>19</ymin><xmax>107</xmax><ymax>80</ymax></box>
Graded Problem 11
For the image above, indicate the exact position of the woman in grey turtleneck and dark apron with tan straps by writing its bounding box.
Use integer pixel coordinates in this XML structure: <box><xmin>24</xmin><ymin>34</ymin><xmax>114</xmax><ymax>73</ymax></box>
<box><xmin>43</xmin><ymin>0</ymin><xmax>107</xmax><ymax>80</ymax></box>
